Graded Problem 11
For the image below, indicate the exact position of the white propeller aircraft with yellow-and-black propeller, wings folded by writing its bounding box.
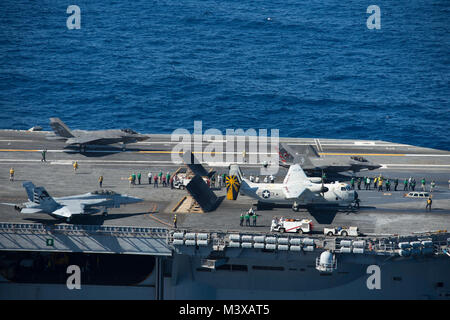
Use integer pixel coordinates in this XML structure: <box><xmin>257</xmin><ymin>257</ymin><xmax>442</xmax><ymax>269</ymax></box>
<box><xmin>229</xmin><ymin>164</ymin><xmax>357</xmax><ymax>211</ymax></box>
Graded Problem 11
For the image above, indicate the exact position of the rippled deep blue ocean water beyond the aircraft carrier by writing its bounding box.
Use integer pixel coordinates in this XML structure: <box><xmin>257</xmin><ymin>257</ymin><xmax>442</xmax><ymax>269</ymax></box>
<box><xmin>0</xmin><ymin>0</ymin><xmax>450</xmax><ymax>150</ymax></box>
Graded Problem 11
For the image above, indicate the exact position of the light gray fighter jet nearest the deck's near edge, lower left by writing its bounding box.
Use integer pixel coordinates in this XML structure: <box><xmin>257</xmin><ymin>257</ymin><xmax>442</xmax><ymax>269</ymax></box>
<box><xmin>4</xmin><ymin>181</ymin><xmax>143</xmax><ymax>222</ymax></box>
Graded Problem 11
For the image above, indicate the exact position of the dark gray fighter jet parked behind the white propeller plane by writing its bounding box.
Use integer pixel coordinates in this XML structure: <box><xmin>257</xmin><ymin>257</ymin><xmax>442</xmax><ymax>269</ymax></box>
<box><xmin>279</xmin><ymin>143</ymin><xmax>381</xmax><ymax>175</ymax></box>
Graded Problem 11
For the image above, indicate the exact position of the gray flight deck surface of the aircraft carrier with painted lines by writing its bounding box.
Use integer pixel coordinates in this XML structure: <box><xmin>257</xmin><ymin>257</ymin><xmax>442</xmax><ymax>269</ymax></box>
<box><xmin>0</xmin><ymin>130</ymin><xmax>450</xmax><ymax>235</ymax></box>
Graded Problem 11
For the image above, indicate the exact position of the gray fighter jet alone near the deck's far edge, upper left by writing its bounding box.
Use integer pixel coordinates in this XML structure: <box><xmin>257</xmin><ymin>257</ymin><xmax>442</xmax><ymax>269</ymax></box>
<box><xmin>49</xmin><ymin>118</ymin><xmax>149</xmax><ymax>152</ymax></box>
